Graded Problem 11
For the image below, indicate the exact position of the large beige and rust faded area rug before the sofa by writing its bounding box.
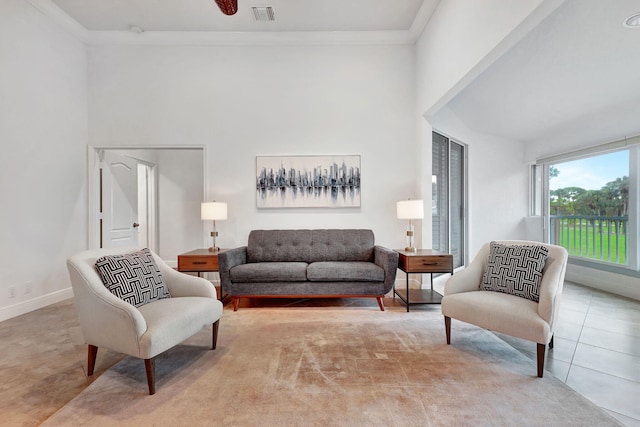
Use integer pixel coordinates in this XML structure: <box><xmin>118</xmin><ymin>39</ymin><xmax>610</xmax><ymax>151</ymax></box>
<box><xmin>44</xmin><ymin>306</ymin><xmax>621</xmax><ymax>426</ymax></box>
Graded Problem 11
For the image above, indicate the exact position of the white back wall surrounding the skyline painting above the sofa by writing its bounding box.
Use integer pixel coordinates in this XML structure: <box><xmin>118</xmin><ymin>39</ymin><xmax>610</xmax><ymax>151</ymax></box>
<box><xmin>89</xmin><ymin>46</ymin><xmax>417</xmax><ymax>251</ymax></box>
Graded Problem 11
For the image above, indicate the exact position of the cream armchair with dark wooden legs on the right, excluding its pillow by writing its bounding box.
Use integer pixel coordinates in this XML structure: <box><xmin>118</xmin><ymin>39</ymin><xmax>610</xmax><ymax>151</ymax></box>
<box><xmin>441</xmin><ymin>240</ymin><xmax>568</xmax><ymax>377</ymax></box>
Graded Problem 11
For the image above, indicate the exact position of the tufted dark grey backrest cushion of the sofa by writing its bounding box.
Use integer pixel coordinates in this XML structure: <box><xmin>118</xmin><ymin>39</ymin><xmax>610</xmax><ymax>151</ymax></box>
<box><xmin>247</xmin><ymin>229</ymin><xmax>375</xmax><ymax>263</ymax></box>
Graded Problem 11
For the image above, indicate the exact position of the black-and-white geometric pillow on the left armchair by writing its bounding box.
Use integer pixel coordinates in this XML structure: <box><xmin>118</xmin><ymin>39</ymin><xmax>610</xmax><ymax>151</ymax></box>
<box><xmin>96</xmin><ymin>248</ymin><xmax>171</xmax><ymax>307</ymax></box>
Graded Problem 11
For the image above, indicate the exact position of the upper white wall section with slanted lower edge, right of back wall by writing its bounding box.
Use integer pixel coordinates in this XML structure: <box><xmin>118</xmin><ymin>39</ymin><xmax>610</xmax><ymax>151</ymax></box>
<box><xmin>417</xmin><ymin>0</ymin><xmax>562</xmax><ymax>113</ymax></box>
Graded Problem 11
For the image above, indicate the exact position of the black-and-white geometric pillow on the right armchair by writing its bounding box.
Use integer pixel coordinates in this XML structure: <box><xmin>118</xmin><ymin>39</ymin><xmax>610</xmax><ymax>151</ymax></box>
<box><xmin>480</xmin><ymin>242</ymin><xmax>549</xmax><ymax>302</ymax></box>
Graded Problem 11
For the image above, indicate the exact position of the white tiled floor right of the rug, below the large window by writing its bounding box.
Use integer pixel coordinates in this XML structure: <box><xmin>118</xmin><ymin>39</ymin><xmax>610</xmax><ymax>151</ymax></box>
<box><xmin>498</xmin><ymin>282</ymin><xmax>640</xmax><ymax>426</ymax></box>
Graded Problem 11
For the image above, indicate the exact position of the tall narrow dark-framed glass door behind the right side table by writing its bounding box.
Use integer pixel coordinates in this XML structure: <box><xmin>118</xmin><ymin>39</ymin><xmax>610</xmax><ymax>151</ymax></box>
<box><xmin>431</xmin><ymin>132</ymin><xmax>466</xmax><ymax>268</ymax></box>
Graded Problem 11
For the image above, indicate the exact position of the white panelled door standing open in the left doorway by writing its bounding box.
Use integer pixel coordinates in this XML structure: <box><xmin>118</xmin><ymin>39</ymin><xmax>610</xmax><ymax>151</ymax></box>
<box><xmin>102</xmin><ymin>150</ymin><xmax>139</xmax><ymax>248</ymax></box>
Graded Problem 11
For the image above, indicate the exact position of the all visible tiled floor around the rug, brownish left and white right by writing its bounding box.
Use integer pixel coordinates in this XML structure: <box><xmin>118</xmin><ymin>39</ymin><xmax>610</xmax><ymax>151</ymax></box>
<box><xmin>0</xmin><ymin>280</ymin><xmax>640</xmax><ymax>427</ymax></box>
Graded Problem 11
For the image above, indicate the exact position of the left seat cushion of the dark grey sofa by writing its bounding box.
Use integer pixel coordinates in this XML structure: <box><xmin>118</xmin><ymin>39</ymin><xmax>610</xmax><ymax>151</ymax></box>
<box><xmin>229</xmin><ymin>262</ymin><xmax>308</xmax><ymax>283</ymax></box>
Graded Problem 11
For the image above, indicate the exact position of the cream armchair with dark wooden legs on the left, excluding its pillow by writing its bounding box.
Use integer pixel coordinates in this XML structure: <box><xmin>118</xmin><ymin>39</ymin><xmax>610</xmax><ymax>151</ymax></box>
<box><xmin>67</xmin><ymin>248</ymin><xmax>222</xmax><ymax>394</ymax></box>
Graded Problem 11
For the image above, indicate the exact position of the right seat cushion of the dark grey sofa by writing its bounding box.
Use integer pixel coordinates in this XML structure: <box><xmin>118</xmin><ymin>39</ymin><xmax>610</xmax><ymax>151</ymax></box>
<box><xmin>307</xmin><ymin>261</ymin><xmax>384</xmax><ymax>282</ymax></box>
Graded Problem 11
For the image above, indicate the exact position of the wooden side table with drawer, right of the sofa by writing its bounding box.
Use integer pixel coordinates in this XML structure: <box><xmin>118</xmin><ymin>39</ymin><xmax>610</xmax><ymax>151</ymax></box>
<box><xmin>393</xmin><ymin>249</ymin><xmax>453</xmax><ymax>311</ymax></box>
